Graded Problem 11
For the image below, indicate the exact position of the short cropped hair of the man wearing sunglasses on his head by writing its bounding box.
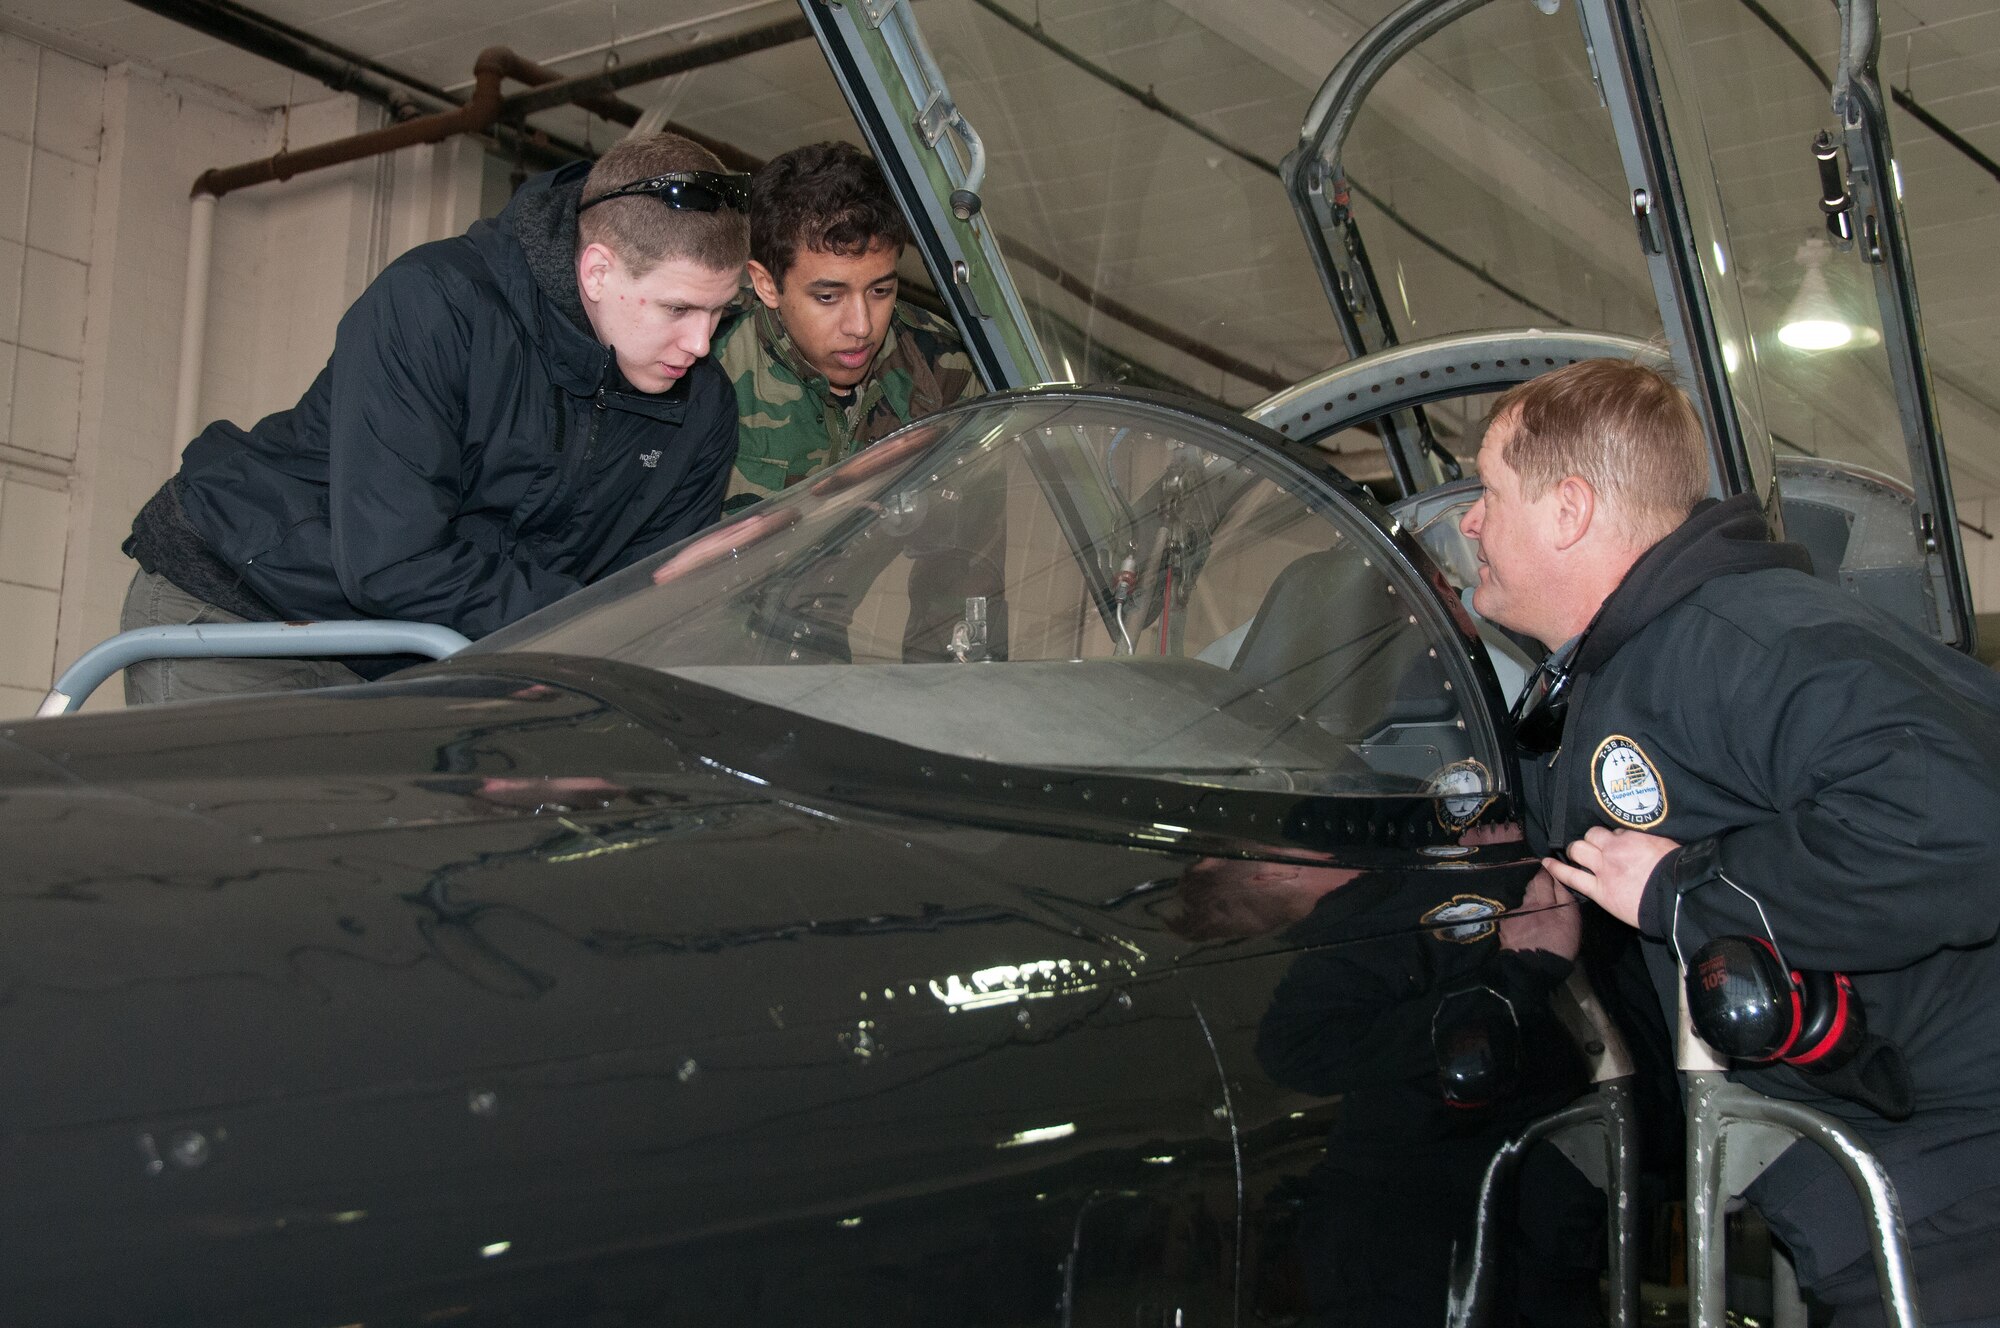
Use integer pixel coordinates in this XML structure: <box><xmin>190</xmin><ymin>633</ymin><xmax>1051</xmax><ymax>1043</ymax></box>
<box><xmin>576</xmin><ymin>134</ymin><xmax>750</xmax><ymax>276</ymax></box>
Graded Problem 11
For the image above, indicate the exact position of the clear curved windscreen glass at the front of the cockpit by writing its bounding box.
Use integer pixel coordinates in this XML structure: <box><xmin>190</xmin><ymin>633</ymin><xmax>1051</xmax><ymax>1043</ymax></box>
<box><xmin>474</xmin><ymin>394</ymin><xmax>1500</xmax><ymax>794</ymax></box>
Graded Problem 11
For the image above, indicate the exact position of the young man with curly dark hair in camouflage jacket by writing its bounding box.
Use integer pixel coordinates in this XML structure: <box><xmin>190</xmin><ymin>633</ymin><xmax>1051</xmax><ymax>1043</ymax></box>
<box><xmin>716</xmin><ymin>142</ymin><xmax>984</xmax><ymax>512</ymax></box>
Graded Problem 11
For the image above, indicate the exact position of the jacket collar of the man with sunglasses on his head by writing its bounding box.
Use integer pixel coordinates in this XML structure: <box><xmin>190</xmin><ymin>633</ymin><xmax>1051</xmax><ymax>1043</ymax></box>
<box><xmin>466</xmin><ymin>162</ymin><xmax>692</xmax><ymax>422</ymax></box>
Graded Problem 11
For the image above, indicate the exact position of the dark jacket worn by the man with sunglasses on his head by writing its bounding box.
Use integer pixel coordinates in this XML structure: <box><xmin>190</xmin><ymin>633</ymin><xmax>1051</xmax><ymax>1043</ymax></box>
<box><xmin>164</xmin><ymin>164</ymin><xmax>736</xmax><ymax>638</ymax></box>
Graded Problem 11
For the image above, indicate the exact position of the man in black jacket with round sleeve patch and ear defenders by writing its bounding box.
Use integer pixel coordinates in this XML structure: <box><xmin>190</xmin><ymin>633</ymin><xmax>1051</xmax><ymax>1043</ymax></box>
<box><xmin>1464</xmin><ymin>360</ymin><xmax>2000</xmax><ymax>1324</ymax></box>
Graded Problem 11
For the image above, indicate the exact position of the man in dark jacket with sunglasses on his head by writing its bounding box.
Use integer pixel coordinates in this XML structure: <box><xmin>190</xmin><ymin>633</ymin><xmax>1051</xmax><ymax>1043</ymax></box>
<box><xmin>124</xmin><ymin>134</ymin><xmax>750</xmax><ymax>702</ymax></box>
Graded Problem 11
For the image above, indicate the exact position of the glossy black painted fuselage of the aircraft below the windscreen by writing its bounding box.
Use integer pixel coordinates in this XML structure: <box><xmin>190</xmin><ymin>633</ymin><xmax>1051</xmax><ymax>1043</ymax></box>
<box><xmin>0</xmin><ymin>656</ymin><xmax>1550</xmax><ymax>1324</ymax></box>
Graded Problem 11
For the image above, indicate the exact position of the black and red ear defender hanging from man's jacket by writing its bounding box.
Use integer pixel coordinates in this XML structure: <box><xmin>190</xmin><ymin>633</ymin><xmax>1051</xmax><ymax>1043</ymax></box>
<box><xmin>1688</xmin><ymin>936</ymin><xmax>1868</xmax><ymax>1074</ymax></box>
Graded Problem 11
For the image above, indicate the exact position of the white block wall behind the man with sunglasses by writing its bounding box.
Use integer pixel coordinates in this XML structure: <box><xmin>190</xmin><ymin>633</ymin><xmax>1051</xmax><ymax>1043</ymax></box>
<box><xmin>0</xmin><ymin>32</ymin><xmax>482</xmax><ymax>718</ymax></box>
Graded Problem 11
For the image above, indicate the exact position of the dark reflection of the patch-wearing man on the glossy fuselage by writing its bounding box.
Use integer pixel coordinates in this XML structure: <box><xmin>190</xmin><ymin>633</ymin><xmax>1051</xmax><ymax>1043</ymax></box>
<box><xmin>1170</xmin><ymin>860</ymin><xmax>1604</xmax><ymax>1324</ymax></box>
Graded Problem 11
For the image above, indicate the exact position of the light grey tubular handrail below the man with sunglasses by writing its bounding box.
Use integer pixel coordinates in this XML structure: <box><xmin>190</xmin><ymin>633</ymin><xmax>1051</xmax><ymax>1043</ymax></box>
<box><xmin>36</xmin><ymin>618</ymin><xmax>472</xmax><ymax>718</ymax></box>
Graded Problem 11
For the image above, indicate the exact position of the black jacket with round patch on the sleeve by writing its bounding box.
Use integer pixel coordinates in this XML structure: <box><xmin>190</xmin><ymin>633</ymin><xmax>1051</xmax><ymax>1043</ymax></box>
<box><xmin>1526</xmin><ymin>498</ymin><xmax>2000</xmax><ymax>1272</ymax></box>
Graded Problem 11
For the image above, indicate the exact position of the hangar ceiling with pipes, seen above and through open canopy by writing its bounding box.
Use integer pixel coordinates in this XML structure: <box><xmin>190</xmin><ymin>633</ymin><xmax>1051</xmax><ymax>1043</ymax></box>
<box><xmin>0</xmin><ymin>0</ymin><xmax>2000</xmax><ymax>496</ymax></box>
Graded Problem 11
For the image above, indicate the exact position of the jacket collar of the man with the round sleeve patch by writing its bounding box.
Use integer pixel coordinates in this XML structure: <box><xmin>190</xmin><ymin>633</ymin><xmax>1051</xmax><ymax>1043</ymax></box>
<box><xmin>1576</xmin><ymin>494</ymin><xmax>1812</xmax><ymax>674</ymax></box>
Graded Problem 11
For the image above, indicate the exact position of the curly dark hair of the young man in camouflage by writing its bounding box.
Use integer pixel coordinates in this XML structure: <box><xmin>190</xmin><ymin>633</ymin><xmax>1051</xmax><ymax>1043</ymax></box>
<box><xmin>750</xmin><ymin>142</ymin><xmax>910</xmax><ymax>286</ymax></box>
